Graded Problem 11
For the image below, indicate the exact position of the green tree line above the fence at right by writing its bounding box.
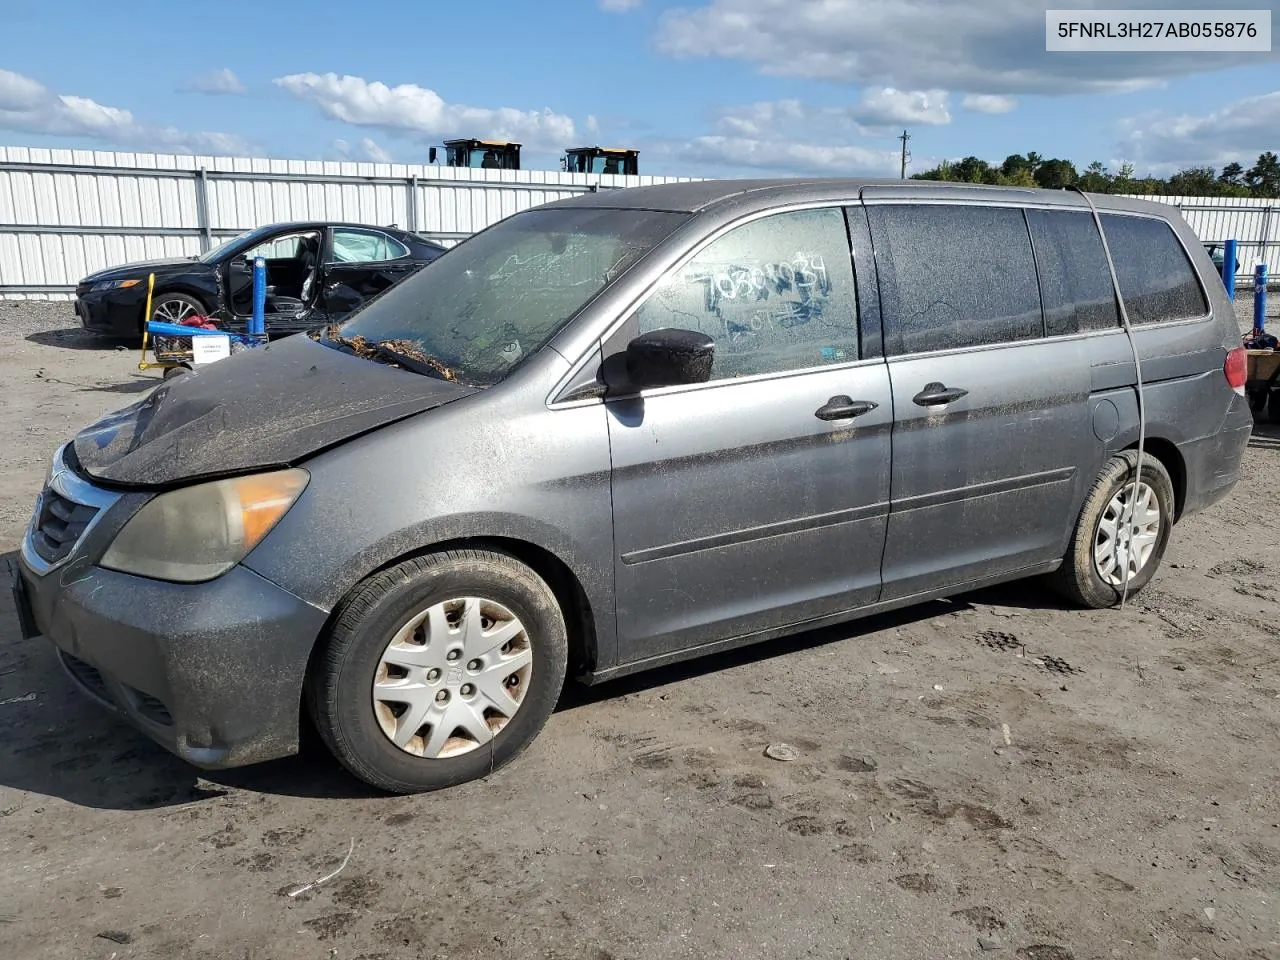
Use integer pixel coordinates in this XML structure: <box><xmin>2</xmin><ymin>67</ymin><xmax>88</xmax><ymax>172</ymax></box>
<box><xmin>911</xmin><ymin>150</ymin><xmax>1280</xmax><ymax>198</ymax></box>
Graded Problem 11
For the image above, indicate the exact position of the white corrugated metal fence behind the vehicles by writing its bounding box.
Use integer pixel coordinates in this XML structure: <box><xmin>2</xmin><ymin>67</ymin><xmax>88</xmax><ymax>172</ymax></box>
<box><xmin>0</xmin><ymin>147</ymin><xmax>1280</xmax><ymax>300</ymax></box>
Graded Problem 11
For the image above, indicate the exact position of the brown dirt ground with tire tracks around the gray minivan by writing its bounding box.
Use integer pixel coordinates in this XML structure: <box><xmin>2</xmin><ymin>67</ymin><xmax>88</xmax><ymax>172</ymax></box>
<box><xmin>0</xmin><ymin>297</ymin><xmax>1280</xmax><ymax>960</ymax></box>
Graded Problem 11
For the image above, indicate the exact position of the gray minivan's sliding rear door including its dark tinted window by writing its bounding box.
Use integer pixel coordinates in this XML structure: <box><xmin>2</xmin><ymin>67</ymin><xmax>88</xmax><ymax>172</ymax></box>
<box><xmin>867</xmin><ymin>198</ymin><xmax>1093</xmax><ymax>599</ymax></box>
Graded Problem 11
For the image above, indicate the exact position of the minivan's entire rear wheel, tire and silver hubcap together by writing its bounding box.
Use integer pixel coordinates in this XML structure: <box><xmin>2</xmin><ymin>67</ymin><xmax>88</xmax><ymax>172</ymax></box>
<box><xmin>1055</xmin><ymin>451</ymin><xmax>1174</xmax><ymax>609</ymax></box>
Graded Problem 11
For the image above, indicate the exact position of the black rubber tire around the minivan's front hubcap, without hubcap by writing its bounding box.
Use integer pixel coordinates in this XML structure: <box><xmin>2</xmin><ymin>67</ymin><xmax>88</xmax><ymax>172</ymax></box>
<box><xmin>306</xmin><ymin>550</ymin><xmax>568</xmax><ymax>794</ymax></box>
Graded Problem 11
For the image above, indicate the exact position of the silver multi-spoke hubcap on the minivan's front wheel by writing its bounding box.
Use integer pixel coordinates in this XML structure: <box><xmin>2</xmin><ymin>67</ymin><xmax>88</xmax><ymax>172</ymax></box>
<box><xmin>372</xmin><ymin>596</ymin><xmax>534</xmax><ymax>759</ymax></box>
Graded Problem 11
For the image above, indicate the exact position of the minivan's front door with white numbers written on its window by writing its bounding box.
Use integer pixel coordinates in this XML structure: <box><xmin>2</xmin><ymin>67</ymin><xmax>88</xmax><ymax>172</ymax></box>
<box><xmin>604</xmin><ymin>207</ymin><xmax>892</xmax><ymax>663</ymax></box>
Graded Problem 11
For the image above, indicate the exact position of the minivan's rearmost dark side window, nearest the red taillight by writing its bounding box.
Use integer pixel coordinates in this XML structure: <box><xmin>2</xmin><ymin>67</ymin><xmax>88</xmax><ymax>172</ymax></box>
<box><xmin>1102</xmin><ymin>214</ymin><xmax>1208</xmax><ymax>324</ymax></box>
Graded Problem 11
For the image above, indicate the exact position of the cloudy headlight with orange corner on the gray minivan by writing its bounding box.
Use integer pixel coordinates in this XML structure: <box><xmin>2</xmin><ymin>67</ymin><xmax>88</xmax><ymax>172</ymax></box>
<box><xmin>100</xmin><ymin>468</ymin><xmax>310</xmax><ymax>584</ymax></box>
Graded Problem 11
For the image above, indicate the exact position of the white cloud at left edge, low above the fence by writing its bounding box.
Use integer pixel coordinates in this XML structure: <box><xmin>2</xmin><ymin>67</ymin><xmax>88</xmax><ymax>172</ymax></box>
<box><xmin>0</xmin><ymin>70</ymin><xmax>252</xmax><ymax>155</ymax></box>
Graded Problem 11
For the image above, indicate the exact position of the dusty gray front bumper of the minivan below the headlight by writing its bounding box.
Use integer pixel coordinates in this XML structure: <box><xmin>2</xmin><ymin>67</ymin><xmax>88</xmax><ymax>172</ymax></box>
<box><xmin>14</xmin><ymin>463</ymin><xmax>326</xmax><ymax>769</ymax></box>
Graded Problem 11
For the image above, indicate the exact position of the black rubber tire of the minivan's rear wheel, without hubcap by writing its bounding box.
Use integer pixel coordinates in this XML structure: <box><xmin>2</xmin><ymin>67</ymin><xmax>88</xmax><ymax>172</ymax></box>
<box><xmin>1052</xmin><ymin>451</ymin><xmax>1174</xmax><ymax>609</ymax></box>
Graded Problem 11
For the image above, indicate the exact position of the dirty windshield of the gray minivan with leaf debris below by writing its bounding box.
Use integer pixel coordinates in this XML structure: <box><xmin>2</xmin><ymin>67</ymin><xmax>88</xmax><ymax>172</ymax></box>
<box><xmin>324</xmin><ymin>207</ymin><xmax>687</xmax><ymax>385</ymax></box>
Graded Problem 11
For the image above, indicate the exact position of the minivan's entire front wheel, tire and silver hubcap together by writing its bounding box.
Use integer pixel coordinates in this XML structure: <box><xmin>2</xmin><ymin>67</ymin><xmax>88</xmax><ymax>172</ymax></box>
<box><xmin>307</xmin><ymin>550</ymin><xmax>568</xmax><ymax>794</ymax></box>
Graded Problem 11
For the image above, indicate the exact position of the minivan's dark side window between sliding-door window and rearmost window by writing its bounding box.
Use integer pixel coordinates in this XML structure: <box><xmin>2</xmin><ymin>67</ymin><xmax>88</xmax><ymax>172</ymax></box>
<box><xmin>1027</xmin><ymin>210</ymin><xmax>1120</xmax><ymax>337</ymax></box>
